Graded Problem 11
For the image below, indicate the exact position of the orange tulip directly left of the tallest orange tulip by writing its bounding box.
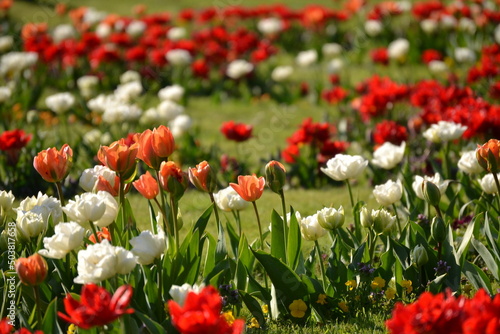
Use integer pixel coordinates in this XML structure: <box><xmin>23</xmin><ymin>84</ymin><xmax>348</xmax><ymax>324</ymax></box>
<box><xmin>97</xmin><ymin>138</ymin><xmax>139</xmax><ymax>180</ymax></box>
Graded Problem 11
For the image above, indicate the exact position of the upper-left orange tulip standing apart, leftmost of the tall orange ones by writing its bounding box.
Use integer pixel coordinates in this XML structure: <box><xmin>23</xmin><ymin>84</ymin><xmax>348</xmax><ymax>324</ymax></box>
<box><xmin>33</xmin><ymin>144</ymin><xmax>73</xmax><ymax>182</ymax></box>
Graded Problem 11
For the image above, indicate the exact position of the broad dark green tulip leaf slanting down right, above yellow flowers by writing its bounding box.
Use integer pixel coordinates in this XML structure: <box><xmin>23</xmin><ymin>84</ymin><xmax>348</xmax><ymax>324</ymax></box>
<box><xmin>252</xmin><ymin>250</ymin><xmax>308</xmax><ymax>312</ymax></box>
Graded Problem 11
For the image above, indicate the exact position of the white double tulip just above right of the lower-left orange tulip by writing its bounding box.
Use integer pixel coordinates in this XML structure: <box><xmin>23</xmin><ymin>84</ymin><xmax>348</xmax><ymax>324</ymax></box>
<box><xmin>38</xmin><ymin>222</ymin><xmax>85</xmax><ymax>259</ymax></box>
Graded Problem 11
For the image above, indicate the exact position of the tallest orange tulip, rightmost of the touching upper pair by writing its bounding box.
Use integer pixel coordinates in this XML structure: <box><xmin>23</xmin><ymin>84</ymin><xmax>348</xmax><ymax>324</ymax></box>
<box><xmin>137</xmin><ymin>125</ymin><xmax>175</xmax><ymax>170</ymax></box>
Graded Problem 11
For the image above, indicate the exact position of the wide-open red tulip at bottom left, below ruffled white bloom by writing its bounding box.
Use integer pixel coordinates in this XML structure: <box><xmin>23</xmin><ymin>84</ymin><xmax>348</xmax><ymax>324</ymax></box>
<box><xmin>58</xmin><ymin>284</ymin><xmax>134</xmax><ymax>329</ymax></box>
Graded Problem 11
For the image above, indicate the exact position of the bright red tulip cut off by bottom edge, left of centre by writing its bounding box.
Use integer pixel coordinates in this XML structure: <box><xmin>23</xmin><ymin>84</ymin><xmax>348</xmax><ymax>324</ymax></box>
<box><xmin>168</xmin><ymin>286</ymin><xmax>245</xmax><ymax>334</ymax></box>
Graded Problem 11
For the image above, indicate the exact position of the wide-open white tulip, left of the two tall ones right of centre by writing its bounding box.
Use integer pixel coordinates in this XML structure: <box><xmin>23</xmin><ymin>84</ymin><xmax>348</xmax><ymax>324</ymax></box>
<box><xmin>321</xmin><ymin>154</ymin><xmax>368</xmax><ymax>181</ymax></box>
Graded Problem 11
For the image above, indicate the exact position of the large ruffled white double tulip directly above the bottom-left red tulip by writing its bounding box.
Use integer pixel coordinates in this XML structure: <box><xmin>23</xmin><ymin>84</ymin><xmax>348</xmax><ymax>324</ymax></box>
<box><xmin>74</xmin><ymin>239</ymin><xmax>136</xmax><ymax>284</ymax></box>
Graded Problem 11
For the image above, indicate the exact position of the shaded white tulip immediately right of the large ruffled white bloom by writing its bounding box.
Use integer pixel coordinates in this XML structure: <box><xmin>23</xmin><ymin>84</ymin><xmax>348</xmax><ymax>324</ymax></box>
<box><xmin>130</xmin><ymin>230</ymin><xmax>167</xmax><ymax>265</ymax></box>
